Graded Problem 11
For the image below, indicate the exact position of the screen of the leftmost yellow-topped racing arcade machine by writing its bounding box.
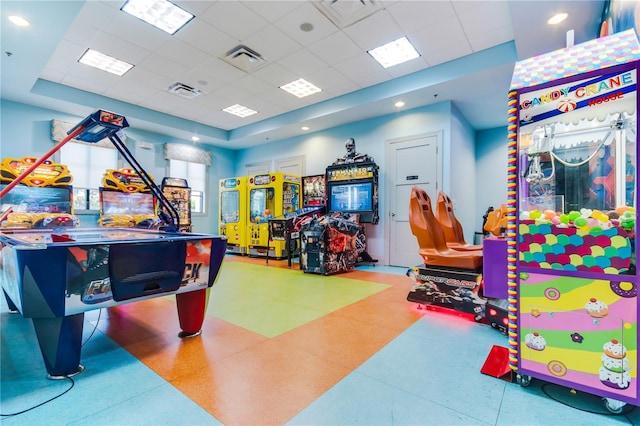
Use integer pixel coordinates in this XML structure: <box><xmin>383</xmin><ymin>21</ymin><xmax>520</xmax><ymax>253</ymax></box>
<box><xmin>0</xmin><ymin>185</ymin><xmax>73</xmax><ymax>214</ymax></box>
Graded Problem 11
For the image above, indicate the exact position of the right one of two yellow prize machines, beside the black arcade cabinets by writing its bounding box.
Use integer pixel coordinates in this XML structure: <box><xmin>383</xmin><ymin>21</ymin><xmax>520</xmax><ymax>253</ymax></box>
<box><xmin>248</xmin><ymin>172</ymin><xmax>302</xmax><ymax>259</ymax></box>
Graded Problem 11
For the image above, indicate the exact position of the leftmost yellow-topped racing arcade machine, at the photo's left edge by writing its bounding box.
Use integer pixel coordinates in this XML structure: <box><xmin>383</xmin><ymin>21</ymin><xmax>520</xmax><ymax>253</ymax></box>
<box><xmin>0</xmin><ymin>157</ymin><xmax>80</xmax><ymax>229</ymax></box>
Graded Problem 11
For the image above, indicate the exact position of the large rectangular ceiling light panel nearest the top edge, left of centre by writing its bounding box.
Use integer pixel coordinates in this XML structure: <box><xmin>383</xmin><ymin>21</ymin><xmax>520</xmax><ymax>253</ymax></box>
<box><xmin>120</xmin><ymin>0</ymin><xmax>194</xmax><ymax>35</ymax></box>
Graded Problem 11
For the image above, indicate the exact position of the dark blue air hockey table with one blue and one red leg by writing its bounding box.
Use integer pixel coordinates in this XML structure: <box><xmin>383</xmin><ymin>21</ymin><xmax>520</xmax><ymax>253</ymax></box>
<box><xmin>0</xmin><ymin>228</ymin><xmax>227</xmax><ymax>378</ymax></box>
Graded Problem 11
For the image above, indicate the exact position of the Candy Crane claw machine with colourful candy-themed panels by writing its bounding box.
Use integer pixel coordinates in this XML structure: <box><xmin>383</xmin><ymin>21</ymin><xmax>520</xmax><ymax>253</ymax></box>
<box><xmin>507</xmin><ymin>30</ymin><xmax>640</xmax><ymax>413</ymax></box>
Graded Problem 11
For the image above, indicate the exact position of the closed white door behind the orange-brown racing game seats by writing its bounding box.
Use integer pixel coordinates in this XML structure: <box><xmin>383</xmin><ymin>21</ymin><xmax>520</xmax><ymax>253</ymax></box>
<box><xmin>386</xmin><ymin>133</ymin><xmax>442</xmax><ymax>267</ymax></box>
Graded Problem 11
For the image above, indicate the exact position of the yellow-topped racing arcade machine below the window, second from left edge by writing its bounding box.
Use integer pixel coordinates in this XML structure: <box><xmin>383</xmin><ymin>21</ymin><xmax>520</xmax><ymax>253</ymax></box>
<box><xmin>98</xmin><ymin>168</ymin><xmax>160</xmax><ymax>229</ymax></box>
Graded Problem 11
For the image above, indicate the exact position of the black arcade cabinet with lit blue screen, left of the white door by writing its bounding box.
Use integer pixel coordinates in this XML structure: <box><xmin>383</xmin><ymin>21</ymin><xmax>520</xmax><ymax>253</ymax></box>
<box><xmin>300</xmin><ymin>161</ymin><xmax>378</xmax><ymax>275</ymax></box>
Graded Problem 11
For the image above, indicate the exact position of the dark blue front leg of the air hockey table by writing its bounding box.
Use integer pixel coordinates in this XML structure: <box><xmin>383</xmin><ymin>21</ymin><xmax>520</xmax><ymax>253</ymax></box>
<box><xmin>32</xmin><ymin>313</ymin><xmax>84</xmax><ymax>379</ymax></box>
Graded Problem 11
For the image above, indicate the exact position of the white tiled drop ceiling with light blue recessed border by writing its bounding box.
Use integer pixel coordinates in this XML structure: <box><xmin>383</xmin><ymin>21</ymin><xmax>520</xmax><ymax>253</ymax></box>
<box><xmin>0</xmin><ymin>0</ymin><xmax>604</xmax><ymax>149</ymax></box>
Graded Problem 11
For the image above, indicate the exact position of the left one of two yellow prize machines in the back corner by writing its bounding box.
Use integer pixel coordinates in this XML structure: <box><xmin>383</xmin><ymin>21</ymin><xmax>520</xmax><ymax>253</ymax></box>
<box><xmin>219</xmin><ymin>176</ymin><xmax>248</xmax><ymax>254</ymax></box>
